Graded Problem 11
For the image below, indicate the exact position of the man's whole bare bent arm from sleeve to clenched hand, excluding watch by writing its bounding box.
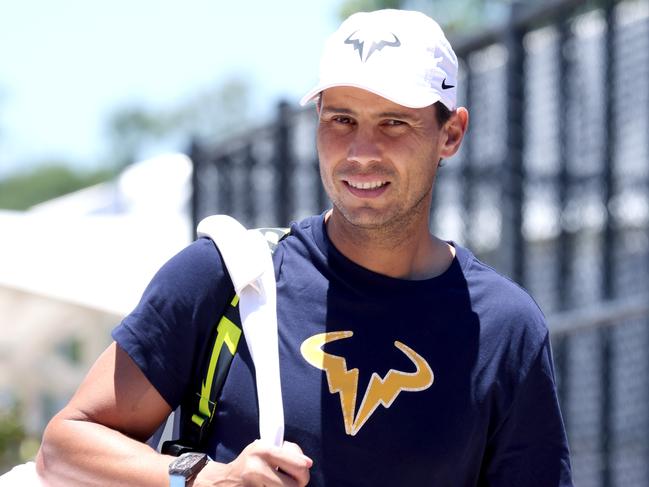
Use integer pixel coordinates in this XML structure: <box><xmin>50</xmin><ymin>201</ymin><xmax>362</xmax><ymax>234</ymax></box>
<box><xmin>36</xmin><ymin>343</ymin><xmax>312</xmax><ymax>487</ymax></box>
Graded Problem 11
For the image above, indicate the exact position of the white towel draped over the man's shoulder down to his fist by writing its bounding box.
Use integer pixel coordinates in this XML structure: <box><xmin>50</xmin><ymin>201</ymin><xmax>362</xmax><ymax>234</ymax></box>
<box><xmin>197</xmin><ymin>215</ymin><xmax>284</xmax><ymax>446</ymax></box>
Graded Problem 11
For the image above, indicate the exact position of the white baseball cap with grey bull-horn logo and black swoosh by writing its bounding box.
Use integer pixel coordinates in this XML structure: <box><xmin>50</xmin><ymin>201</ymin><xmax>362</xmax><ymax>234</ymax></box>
<box><xmin>300</xmin><ymin>9</ymin><xmax>457</xmax><ymax>110</ymax></box>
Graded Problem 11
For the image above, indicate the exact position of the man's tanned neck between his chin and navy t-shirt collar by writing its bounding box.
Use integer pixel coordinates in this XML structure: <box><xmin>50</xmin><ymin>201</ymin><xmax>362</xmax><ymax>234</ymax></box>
<box><xmin>325</xmin><ymin>212</ymin><xmax>455</xmax><ymax>280</ymax></box>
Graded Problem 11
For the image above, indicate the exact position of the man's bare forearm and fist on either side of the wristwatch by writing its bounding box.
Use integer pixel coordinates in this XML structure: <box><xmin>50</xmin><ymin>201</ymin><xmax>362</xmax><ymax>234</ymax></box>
<box><xmin>36</xmin><ymin>417</ymin><xmax>313</xmax><ymax>487</ymax></box>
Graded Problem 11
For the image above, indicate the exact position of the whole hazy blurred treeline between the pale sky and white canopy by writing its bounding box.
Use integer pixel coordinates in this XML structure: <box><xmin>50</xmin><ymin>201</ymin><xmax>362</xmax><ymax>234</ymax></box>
<box><xmin>0</xmin><ymin>78</ymin><xmax>250</xmax><ymax>210</ymax></box>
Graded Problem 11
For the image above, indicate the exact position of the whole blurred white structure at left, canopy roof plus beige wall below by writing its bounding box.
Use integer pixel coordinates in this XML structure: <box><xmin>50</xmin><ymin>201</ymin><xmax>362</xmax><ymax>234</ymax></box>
<box><xmin>0</xmin><ymin>154</ymin><xmax>192</xmax><ymax>434</ymax></box>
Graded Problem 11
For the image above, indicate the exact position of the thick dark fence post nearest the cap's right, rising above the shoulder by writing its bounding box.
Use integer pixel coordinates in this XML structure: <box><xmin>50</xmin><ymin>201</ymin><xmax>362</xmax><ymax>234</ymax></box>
<box><xmin>502</xmin><ymin>2</ymin><xmax>525</xmax><ymax>285</ymax></box>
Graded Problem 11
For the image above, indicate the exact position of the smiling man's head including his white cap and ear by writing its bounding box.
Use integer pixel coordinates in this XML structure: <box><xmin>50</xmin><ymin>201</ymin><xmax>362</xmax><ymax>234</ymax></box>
<box><xmin>302</xmin><ymin>10</ymin><xmax>468</xmax><ymax>234</ymax></box>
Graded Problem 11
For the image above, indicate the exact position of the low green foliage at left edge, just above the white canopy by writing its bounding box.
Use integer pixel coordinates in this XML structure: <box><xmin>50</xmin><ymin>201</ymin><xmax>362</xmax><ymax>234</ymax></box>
<box><xmin>0</xmin><ymin>163</ymin><xmax>115</xmax><ymax>210</ymax></box>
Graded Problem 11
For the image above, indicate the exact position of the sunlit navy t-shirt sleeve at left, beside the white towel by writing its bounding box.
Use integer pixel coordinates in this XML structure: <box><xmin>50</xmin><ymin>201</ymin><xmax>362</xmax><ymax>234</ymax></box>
<box><xmin>112</xmin><ymin>238</ymin><xmax>234</xmax><ymax>409</ymax></box>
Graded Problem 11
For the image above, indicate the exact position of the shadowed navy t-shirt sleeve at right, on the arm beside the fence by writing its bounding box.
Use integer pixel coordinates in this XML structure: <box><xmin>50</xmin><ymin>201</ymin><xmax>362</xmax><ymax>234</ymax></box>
<box><xmin>480</xmin><ymin>336</ymin><xmax>573</xmax><ymax>487</ymax></box>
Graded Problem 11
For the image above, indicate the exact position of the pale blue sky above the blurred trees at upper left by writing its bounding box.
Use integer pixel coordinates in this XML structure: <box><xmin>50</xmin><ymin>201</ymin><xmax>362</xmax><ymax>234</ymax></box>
<box><xmin>0</xmin><ymin>0</ymin><xmax>341</xmax><ymax>175</ymax></box>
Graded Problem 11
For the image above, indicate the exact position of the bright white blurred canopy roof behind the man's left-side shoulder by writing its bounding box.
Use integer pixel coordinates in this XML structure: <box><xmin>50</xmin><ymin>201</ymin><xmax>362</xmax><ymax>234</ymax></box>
<box><xmin>0</xmin><ymin>155</ymin><xmax>191</xmax><ymax>315</ymax></box>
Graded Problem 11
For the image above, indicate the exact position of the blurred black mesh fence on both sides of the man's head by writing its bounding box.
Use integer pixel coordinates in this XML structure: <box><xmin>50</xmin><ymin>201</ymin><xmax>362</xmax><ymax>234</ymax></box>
<box><xmin>191</xmin><ymin>0</ymin><xmax>649</xmax><ymax>487</ymax></box>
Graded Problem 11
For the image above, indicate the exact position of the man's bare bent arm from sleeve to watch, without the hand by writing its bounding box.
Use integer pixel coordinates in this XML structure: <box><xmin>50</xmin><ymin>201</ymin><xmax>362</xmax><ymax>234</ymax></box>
<box><xmin>37</xmin><ymin>343</ymin><xmax>171</xmax><ymax>486</ymax></box>
